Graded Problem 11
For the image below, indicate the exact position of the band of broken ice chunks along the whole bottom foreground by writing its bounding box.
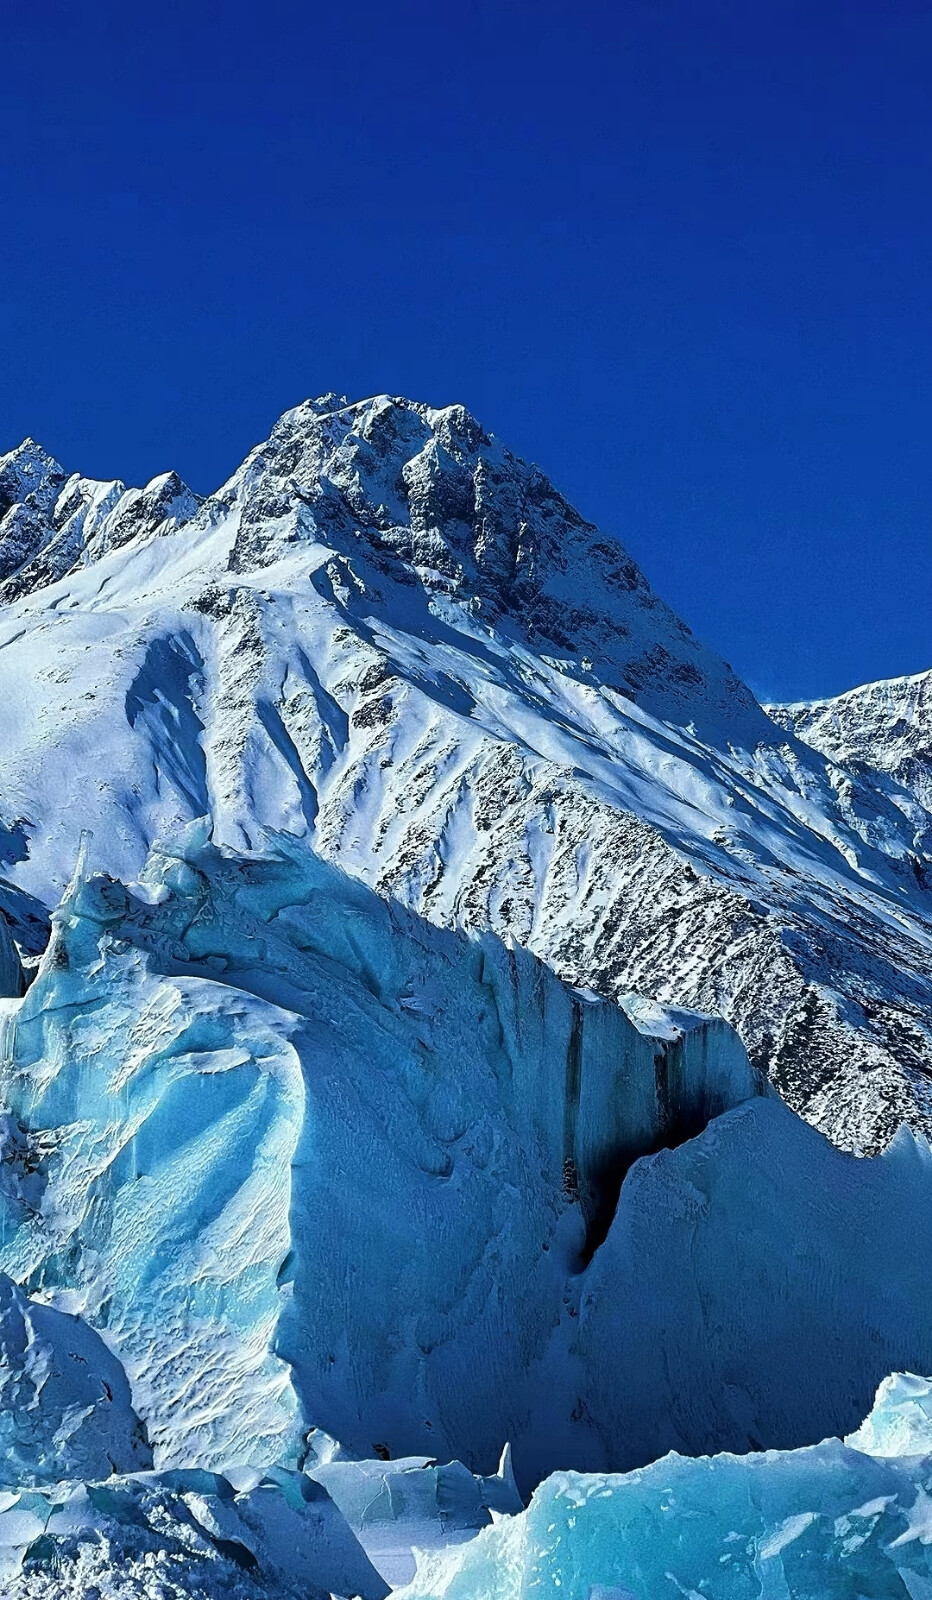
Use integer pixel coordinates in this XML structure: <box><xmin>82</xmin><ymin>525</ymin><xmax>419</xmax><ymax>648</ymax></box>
<box><xmin>9</xmin><ymin>1373</ymin><xmax>932</xmax><ymax>1600</ymax></box>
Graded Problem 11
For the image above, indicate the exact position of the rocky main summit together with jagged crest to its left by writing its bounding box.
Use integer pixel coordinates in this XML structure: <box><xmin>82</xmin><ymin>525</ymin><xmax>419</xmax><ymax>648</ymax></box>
<box><xmin>0</xmin><ymin>392</ymin><xmax>772</xmax><ymax>744</ymax></box>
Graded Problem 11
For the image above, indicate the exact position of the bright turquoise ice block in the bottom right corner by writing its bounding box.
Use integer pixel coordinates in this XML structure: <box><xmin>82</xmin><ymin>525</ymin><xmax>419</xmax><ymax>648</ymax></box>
<box><xmin>402</xmin><ymin>1374</ymin><xmax>932</xmax><ymax>1600</ymax></box>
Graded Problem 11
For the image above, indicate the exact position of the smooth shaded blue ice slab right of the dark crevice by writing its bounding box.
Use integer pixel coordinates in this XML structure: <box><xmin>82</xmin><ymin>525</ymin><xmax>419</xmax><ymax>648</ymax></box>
<box><xmin>580</xmin><ymin>1101</ymin><xmax>932</xmax><ymax>1466</ymax></box>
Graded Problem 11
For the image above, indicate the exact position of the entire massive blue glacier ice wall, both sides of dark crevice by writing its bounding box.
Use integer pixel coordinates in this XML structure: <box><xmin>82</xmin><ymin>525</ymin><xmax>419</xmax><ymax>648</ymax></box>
<box><xmin>0</xmin><ymin>827</ymin><xmax>932</xmax><ymax>1490</ymax></box>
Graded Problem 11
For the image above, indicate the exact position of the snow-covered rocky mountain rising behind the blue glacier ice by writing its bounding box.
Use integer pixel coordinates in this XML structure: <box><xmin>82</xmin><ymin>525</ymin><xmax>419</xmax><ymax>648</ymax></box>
<box><xmin>0</xmin><ymin>395</ymin><xmax>932</xmax><ymax>1150</ymax></box>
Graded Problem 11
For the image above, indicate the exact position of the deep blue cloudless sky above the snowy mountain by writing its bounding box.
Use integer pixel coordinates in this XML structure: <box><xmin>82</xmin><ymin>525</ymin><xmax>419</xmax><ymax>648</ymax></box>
<box><xmin>0</xmin><ymin>0</ymin><xmax>932</xmax><ymax>696</ymax></box>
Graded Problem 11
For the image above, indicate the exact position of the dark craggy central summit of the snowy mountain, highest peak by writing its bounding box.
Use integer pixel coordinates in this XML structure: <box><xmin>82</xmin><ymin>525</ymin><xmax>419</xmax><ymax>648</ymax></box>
<box><xmin>208</xmin><ymin>394</ymin><xmax>772</xmax><ymax>742</ymax></box>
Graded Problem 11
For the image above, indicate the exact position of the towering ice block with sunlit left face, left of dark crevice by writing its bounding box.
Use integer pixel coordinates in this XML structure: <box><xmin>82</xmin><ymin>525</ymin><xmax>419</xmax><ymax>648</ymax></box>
<box><xmin>0</xmin><ymin>826</ymin><xmax>767</xmax><ymax>1477</ymax></box>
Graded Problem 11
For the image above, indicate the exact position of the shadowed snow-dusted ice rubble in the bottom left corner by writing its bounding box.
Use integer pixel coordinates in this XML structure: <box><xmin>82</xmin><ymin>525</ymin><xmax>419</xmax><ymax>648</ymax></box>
<box><xmin>0</xmin><ymin>1274</ymin><xmax>390</xmax><ymax>1600</ymax></box>
